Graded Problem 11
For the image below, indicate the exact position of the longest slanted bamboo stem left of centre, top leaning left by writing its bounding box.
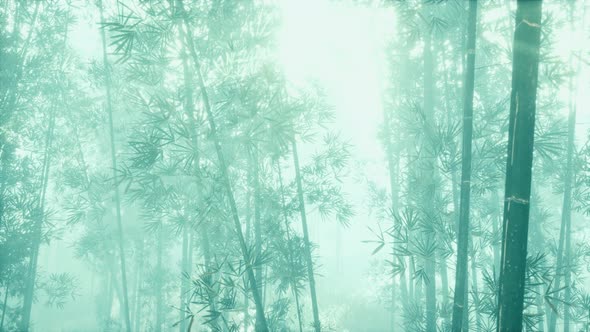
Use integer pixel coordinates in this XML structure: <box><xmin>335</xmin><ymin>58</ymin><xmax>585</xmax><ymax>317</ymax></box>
<box><xmin>177</xmin><ymin>0</ymin><xmax>268</xmax><ymax>332</ymax></box>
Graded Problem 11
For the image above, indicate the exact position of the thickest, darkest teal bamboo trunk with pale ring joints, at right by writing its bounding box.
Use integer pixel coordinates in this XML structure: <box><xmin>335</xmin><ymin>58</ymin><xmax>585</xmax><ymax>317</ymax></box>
<box><xmin>497</xmin><ymin>0</ymin><xmax>541</xmax><ymax>331</ymax></box>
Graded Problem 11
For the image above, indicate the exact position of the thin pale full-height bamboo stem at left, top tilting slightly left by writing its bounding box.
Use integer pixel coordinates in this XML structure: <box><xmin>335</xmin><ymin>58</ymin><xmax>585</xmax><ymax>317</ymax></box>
<box><xmin>98</xmin><ymin>0</ymin><xmax>131</xmax><ymax>332</ymax></box>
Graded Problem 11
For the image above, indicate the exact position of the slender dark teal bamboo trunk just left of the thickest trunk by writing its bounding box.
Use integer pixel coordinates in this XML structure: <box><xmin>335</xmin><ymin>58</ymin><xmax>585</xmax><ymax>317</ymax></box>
<box><xmin>452</xmin><ymin>0</ymin><xmax>477</xmax><ymax>331</ymax></box>
